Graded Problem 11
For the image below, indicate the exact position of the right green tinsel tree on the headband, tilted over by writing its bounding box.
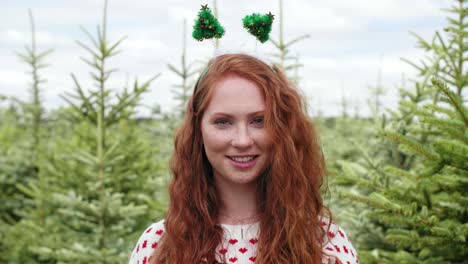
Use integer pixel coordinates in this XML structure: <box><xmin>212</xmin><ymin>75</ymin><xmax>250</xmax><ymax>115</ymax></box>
<box><xmin>242</xmin><ymin>12</ymin><xmax>275</xmax><ymax>43</ymax></box>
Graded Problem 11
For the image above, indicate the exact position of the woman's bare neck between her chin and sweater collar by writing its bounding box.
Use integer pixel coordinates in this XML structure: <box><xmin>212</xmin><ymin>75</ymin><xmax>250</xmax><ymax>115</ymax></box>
<box><xmin>215</xmin><ymin>177</ymin><xmax>259</xmax><ymax>225</ymax></box>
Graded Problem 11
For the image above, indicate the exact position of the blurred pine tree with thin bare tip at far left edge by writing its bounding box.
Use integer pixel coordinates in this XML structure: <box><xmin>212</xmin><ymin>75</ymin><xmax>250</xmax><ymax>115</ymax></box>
<box><xmin>0</xmin><ymin>10</ymin><xmax>52</xmax><ymax>263</ymax></box>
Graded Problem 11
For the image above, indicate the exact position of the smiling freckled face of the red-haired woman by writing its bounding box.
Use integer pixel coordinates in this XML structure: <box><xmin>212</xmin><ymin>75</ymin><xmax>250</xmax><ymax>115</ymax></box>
<box><xmin>201</xmin><ymin>75</ymin><xmax>270</xmax><ymax>186</ymax></box>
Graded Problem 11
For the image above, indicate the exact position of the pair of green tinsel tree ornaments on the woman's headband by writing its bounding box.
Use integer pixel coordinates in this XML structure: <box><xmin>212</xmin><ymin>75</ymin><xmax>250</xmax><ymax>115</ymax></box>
<box><xmin>192</xmin><ymin>5</ymin><xmax>275</xmax><ymax>43</ymax></box>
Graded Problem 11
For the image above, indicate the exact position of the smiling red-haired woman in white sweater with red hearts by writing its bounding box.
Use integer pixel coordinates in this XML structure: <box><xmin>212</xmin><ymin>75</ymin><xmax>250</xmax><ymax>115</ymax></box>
<box><xmin>130</xmin><ymin>54</ymin><xmax>358</xmax><ymax>264</ymax></box>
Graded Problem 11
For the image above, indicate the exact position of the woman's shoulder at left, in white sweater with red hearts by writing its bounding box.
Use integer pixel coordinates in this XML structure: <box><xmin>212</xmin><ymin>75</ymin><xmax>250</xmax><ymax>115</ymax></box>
<box><xmin>129</xmin><ymin>220</ymin><xmax>165</xmax><ymax>264</ymax></box>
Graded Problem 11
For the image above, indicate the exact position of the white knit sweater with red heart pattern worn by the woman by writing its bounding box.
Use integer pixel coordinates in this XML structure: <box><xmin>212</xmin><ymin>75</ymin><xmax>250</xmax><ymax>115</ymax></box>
<box><xmin>129</xmin><ymin>220</ymin><xmax>359</xmax><ymax>264</ymax></box>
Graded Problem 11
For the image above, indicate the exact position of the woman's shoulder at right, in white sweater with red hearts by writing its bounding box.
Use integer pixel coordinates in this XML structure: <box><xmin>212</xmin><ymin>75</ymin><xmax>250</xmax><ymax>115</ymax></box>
<box><xmin>321</xmin><ymin>218</ymin><xmax>359</xmax><ymax>264</ymax></box>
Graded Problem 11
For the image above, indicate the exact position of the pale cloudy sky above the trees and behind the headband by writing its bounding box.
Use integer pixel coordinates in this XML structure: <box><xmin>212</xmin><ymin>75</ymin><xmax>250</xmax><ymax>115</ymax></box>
<box><xmin>0</xmin><ymin>0</ymin><xmax>454</xmax><ymax>115</ymax></box>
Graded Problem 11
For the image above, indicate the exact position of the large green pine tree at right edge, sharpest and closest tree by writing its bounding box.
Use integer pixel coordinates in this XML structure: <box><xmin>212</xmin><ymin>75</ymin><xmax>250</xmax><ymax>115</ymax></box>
<box><xmin>336</xmin><ymin>0</ymin><xmax>468</xmax><ymax>263</ymax></box>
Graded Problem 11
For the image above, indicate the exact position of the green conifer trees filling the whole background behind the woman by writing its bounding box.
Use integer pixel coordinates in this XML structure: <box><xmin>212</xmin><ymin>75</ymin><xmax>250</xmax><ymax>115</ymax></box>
<box><xmin>0</xmin><ymin>0</ymin><xmax>468</xmax><ymax>264</ymax></box>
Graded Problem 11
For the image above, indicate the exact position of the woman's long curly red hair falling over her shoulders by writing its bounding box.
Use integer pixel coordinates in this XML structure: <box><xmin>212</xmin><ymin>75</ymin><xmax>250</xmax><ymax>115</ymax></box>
<box><xmin>152</xmin><ymin>54</ymin><xmax>331</xmax><ymax>264</ymax></box>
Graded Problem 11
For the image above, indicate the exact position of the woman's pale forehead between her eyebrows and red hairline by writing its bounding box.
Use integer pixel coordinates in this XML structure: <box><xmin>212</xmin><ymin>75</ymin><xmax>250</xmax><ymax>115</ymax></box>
<box><xmin>205</xmin><ymin>75</ymin><xmax>265</xmax><ymax>114</ymax></box>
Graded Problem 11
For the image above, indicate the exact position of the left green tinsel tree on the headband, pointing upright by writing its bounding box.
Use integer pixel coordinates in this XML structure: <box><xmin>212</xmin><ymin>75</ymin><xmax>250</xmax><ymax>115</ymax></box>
<box><xmin>192</xmin><ymin>5</ymin><xmax>224</xmax><ymax>41</ymax></box>
